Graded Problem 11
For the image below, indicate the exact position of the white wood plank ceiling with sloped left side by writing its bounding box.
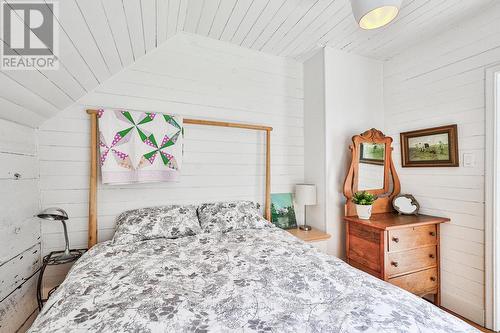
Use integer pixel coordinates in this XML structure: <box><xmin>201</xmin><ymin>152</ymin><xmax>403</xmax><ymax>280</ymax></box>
<box><xmin>0</xmin><ymin>0</ymin><xmax>495</xmax><ymax>127</ymax></box>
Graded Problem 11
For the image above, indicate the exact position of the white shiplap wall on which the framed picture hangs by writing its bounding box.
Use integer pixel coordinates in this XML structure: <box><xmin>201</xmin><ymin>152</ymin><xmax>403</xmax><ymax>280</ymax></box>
<box><xmin>384</xmin><ymin>4</ymin><xmax>500</xmax><ymax>323</ymax></box>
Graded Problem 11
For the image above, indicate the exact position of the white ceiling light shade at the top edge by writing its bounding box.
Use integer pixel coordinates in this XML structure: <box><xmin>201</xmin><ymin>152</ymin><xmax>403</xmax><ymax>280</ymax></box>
<box><xmin>351</xmin><ymin>0</ymin><xmax>402</xmax><ymax>30</ymax></box>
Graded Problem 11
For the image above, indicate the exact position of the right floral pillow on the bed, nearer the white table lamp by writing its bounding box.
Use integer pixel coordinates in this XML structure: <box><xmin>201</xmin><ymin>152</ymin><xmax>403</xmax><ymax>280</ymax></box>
<box><xmin>198</xmin><ymin>201</ymin><xmax>271</xmax><ymax>232</ymax></box>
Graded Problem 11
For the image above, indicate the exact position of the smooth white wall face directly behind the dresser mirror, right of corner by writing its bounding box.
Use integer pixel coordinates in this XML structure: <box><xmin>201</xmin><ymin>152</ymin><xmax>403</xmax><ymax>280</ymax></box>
<box><xmin>325</xmin><ymin>47</ymin><xmax>384</xmax><ymax>258</ymax></box>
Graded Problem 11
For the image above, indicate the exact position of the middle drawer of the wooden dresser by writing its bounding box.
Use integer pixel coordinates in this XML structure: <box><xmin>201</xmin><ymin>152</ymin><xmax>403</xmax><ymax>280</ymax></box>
<box><xmin>386</xmin><ymin>245</ymin><xmax>437</xmax><ymax>277</ymax></box>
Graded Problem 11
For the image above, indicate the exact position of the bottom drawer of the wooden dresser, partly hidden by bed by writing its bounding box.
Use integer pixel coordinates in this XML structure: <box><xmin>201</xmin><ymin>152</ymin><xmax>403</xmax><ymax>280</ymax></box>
<box><xmin>388</xmin><ymin>268</ymin><xmax>438</xmax><ymax>296</ymax></box>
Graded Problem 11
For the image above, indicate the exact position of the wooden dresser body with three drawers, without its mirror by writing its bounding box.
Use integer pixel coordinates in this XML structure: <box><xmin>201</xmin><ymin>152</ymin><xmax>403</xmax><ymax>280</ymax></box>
<box><xmin>344</xmin><ymin>213</ymin><xmax>449</xmax><ymax>306</ymax></box>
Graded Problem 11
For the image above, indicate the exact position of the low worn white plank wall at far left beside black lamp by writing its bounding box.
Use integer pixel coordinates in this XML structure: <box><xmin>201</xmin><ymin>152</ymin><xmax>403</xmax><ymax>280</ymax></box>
<box><xmin>0</xmin><ymin>120</ymin><xmax>40</xmax><ymax>332</ymax></box>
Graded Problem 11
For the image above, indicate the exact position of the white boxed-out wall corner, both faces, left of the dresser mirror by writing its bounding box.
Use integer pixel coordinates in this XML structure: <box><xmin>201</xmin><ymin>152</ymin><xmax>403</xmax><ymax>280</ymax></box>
<box><xmin>304</xmin><ymin>47</ymin><xmax>384</xmax><ymax>258</ymax></box>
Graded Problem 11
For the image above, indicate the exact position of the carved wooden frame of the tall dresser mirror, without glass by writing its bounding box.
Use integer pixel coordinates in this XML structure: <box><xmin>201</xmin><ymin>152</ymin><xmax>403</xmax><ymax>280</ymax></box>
<box><xmin>344</xmin><ymin>128</ymin><xmax>401</xmax><ymax>216</ymax></box>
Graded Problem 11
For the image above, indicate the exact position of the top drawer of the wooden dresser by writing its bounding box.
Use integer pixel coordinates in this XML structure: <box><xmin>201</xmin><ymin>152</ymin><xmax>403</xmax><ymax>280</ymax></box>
<box><xmin>387</xmin><ymin>224</ymin><xmax>437</xmax><ymax>252</ymax></box>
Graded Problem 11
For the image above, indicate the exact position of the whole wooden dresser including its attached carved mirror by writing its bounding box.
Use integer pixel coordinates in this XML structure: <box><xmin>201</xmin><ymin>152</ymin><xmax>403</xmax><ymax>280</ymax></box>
<box><xmin>344</xmin><ymin>128</ymin><xmax>449</xmax><ymax>305</ymax></box>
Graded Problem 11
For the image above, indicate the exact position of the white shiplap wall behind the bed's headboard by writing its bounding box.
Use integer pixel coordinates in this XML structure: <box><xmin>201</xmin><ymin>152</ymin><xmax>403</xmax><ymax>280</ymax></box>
<box><xmin>39</xmin><ymin>33</ymin><xmax>304</xmax><ymax>252</ymax></box>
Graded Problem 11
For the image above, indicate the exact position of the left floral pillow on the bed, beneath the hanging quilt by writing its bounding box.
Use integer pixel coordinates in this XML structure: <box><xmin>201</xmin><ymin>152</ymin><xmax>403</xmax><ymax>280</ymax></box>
<box><xmin>113</xmin><ymin>205</ymin><xmax>201</xmax><ymax>243</ymax></box>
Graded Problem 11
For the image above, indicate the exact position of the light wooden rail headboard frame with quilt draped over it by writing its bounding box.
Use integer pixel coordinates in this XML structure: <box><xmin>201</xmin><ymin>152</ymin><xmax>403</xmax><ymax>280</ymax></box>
<box><xmin>87</xmin><ymin>110</ymin><xmax>273</xmax><ymax>249</ymax></box>
